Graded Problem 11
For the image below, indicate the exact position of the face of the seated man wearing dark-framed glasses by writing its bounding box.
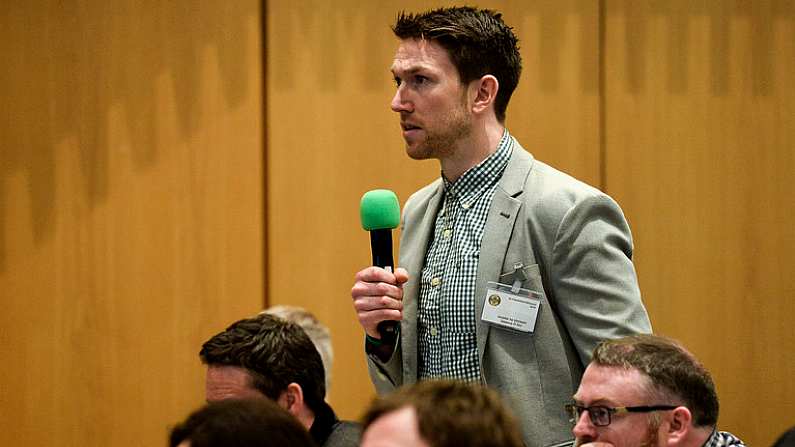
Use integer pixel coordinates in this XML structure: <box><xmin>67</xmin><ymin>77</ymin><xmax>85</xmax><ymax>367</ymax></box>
<box><xmin>572</xmin><ymin>364</ymin><xmax>664</xmax><ymax>447</ymax></box>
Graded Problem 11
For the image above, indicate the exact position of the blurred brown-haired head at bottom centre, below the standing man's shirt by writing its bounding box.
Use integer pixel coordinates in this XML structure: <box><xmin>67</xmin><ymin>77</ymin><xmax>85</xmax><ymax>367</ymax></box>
<box><xmin>362</xmin><ymin>380</ymin><xmax>524</xmax><ymax>447</ymax></box>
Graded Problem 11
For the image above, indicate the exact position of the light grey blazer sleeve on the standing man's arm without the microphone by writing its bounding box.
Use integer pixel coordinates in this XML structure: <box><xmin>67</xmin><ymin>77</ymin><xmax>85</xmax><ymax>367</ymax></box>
<box><xmin>549</xmin><ymin>193</ymin><xmax>652</xmax><ymax>365</ymax></box>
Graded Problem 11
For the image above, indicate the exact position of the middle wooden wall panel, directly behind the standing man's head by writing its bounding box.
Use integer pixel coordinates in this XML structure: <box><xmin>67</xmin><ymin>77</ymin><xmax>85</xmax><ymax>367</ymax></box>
<box><xmin>266</xmin><ymin>0</ymin><xmax>600</xmax><ymax>418</ymax></box>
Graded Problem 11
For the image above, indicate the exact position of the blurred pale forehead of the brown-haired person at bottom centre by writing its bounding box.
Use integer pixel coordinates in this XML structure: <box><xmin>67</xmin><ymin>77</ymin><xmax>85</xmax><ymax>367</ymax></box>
<box><xmin>361</xmin><ymin>407</ymin><xmax>430</xmax><ymax>447</ymax></box>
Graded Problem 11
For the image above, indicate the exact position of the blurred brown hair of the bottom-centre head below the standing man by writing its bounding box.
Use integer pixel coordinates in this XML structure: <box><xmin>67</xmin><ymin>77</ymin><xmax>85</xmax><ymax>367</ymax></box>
<box><xmin>362</xmin><ymin>380</ymin><xmax>524</xmax><ymax>447</ymax></box>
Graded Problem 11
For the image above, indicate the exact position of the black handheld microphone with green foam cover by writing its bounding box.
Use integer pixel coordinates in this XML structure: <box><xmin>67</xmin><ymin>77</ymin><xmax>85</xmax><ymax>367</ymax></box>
<box><xmin>359</xmin><ymin>189</ymin><xmax>400</xmax><ymax>343</ymax></box>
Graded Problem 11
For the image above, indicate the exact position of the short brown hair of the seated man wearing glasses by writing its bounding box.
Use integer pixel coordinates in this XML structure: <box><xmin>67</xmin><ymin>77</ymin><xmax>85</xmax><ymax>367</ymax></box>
<box><xmin>591</xmin><ymin>334</ymin><xmax>719</xmax><ymax>427</ymax></box>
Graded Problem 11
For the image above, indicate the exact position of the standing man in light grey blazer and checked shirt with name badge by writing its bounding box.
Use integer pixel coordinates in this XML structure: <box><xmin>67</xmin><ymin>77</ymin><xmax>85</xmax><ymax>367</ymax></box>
<box><xmin>351</xmin><ymin>7</ymin><xmax>651</xmax><ymax>446</ymax></box>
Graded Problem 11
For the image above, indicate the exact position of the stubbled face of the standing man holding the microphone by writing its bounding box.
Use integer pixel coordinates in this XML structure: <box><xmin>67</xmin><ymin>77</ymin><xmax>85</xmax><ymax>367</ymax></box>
<box><xmin>391</xmin><ymin>39</ymin><xmax>472</xmax><ymax>160</ymax></box>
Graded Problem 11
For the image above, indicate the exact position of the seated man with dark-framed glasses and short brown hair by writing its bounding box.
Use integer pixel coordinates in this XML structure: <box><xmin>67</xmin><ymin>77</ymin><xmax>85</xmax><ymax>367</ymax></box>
<box><xmin>566</xmin><ymin>335</ymin><xmax>745</xmax><ymax>447</ymax></box>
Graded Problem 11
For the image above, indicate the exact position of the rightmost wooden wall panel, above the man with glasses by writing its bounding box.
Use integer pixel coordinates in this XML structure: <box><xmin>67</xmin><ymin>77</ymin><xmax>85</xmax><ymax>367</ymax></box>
<box><xmin>604</xmin><ymin>0</ymin><xmax>795</xmax><ymax>445</ymax></box>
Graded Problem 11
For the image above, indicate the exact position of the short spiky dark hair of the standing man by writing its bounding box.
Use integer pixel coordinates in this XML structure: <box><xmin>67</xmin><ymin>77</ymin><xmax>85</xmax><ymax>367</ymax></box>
<box><xmin>392</xmin><ymin>6</ymin><xmax>522</xmax><ymax>123</ymax></box>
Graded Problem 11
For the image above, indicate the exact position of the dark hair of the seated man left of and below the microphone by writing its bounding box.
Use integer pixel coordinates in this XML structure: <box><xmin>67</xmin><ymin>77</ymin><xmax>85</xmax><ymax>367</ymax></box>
<box><xmin>199</xmin><ymin>314</ymin><xmax>326</xmax><ymax>413</ymax></box>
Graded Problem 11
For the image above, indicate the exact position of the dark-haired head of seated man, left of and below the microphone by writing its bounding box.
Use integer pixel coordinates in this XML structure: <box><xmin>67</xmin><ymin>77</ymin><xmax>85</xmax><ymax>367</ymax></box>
<box><xmin>199</xmin><ymin>314</ymin><xmax>326</xmax><ymax>428</ymax></box>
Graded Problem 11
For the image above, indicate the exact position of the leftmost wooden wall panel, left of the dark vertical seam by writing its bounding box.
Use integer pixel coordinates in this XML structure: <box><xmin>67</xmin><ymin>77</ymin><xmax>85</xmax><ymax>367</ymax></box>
<box><xmin>0</xmin><ymin>0</ymin><xmax>264</xmax><ymax>446</ymax></box>
